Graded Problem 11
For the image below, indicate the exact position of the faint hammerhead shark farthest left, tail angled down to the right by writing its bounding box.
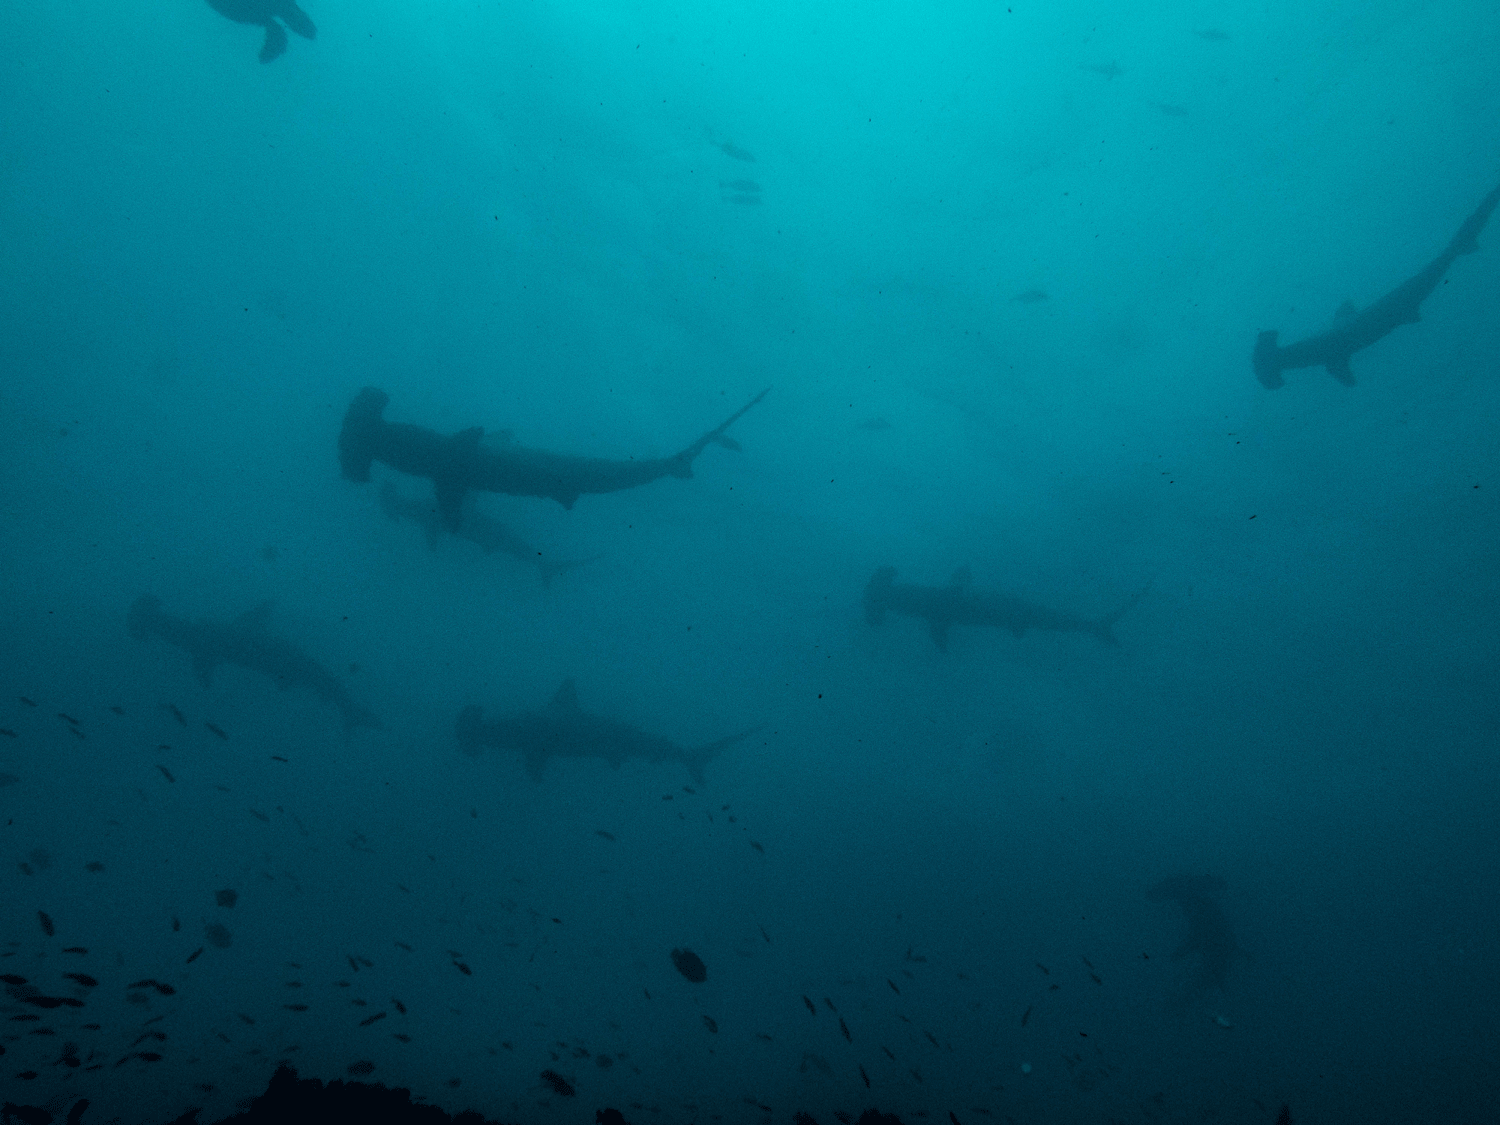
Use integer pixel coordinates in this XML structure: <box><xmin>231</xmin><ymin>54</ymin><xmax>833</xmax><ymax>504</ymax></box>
<box><xmin>129</xmin><ymin>594</ymin><xmax>380</xmax><ymax>732</ymax></box>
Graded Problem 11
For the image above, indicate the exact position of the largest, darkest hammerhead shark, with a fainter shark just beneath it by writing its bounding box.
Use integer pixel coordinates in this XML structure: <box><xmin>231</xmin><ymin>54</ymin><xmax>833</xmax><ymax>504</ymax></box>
<box><xmin>339</xmin><ymin>387</ymin><xmax>771</xmax><ymax>531</ymax></box>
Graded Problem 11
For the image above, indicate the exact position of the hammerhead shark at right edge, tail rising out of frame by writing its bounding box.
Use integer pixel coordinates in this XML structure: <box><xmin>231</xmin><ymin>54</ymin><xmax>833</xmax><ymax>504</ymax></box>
<box><xmin>1251</xmin><ymin>176</ymin><xmax>1500</xmax><ymax>390</ymax></box>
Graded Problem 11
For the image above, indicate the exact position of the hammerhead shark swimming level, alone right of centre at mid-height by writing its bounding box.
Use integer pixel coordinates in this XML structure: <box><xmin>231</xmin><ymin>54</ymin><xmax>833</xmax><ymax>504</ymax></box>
<box><xmin>864</xmin><ymin>567</ymin><xmax>1140</xmax><ymax>653</ymax></box>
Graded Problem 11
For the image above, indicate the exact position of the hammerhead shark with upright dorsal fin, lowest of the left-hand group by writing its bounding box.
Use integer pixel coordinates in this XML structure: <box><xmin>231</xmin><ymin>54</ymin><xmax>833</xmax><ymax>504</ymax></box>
<box><xmin>458</xmin><ymin>680</ymin><xmax>761</xmax><ymax>785</ymax></box>
